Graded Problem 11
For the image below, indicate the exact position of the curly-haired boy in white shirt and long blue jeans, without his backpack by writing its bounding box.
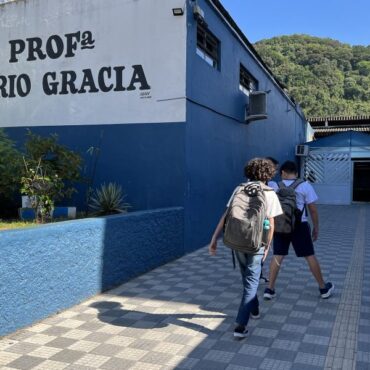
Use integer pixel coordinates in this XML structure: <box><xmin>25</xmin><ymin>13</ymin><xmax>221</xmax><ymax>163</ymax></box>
<box><xmin>208</xmin><ymin>158</ymin><xmax>282</xmax><ymax>338</ymax></box>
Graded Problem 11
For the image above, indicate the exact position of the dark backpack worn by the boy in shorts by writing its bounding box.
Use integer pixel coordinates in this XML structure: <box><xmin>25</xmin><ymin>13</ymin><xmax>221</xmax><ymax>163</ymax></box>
<box><xmin>274</xmin><ymin>179</ymin><xmax>304</xmax><ymax>234</ymax></box>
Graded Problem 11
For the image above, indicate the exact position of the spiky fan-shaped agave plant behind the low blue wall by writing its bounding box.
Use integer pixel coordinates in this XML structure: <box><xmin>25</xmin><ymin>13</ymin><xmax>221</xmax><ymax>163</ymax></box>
<box><xmin>89</xmin><ymin>182</ymin><xmax>130</xmax><ymax>216</ymax></box>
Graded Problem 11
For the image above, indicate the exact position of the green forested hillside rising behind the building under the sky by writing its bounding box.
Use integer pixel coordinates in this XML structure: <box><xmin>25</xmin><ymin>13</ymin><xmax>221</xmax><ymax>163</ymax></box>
<box><xmin>254</xmin><ymin>35</ymin><xmax>370</xmax><ymax>117</ymax></box>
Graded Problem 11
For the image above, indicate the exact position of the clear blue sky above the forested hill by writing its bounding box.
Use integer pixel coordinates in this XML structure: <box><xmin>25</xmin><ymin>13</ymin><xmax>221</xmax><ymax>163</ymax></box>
<box><xmin>221</xmin><ymin>0</ymin><xmax>370</xmax><ymax>46</ymax></box>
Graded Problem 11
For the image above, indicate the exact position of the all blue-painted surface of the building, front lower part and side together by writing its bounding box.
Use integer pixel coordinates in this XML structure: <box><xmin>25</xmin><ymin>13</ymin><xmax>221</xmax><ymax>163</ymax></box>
<box><xmin>2</xmin><ymin>0</ymin><xmax>305</xmax><ymax>294</ymax></box>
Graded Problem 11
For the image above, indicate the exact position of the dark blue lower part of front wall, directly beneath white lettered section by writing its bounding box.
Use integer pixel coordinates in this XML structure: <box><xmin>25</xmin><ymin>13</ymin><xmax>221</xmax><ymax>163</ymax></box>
<box><xmin>6</xmin><ymin>123</ymin><xmax>185</xmax><ymax>210</ymax></box>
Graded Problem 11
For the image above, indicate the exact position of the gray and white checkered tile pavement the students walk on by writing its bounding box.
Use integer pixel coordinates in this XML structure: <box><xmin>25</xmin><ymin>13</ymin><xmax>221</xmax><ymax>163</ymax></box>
<box><xmin>0</xmin><ymin>205</ymin><xmax>370</xmax><ymax>370</ymax></box>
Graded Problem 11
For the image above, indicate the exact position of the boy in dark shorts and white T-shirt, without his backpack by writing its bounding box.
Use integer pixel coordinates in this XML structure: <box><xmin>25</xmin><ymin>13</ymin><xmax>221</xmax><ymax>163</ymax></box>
<box><xmin>263</xmin><ymin>161</ymin><xmax>334</xmax><ymax>300</ymax></box>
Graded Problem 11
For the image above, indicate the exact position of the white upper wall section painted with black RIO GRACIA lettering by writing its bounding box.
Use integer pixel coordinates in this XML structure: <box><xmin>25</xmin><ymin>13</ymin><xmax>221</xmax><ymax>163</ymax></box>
<box><xmin>0</xmin><ymin>0</ymin><xmax>186</xmax><ymax>127</ymax></box>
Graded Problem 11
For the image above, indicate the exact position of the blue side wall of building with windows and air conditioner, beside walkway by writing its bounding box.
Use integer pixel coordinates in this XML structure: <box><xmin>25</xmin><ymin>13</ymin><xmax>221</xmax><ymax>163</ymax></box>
<box><xmin>185</xmin><ymin>0</ymin><xmax>305</xmax><ymax>250</ymax></box>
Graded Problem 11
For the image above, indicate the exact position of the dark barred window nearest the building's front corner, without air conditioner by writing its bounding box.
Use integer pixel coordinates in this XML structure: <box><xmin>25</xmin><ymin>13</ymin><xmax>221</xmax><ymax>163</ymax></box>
<box><xmin>197</xmin><ymin>23</ymin><xmax>220</xmax><ymax>68</ymax></box>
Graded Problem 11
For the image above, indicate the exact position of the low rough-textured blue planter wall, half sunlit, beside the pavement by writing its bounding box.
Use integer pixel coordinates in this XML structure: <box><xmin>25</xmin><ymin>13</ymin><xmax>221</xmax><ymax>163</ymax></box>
<box><xmin>0</xmin><ymin>207</ymin><xmax>184</xmax><ymax>336</ymax></box>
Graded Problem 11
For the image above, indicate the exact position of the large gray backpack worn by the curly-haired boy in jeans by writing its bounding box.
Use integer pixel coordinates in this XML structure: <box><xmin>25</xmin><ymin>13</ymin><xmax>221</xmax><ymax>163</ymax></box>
<box><xmin>223</xmin><ymin>182</ymin><xmax>272</xmax><ymax>254</ymax></box>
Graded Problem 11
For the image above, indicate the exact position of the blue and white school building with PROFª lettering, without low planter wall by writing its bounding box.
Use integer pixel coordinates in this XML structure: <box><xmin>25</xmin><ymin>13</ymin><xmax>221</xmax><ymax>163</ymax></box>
<box><xmin>0</xmin><ymin>0</ymin><xmax>307</xmax><ymax>252</ymax></box>
